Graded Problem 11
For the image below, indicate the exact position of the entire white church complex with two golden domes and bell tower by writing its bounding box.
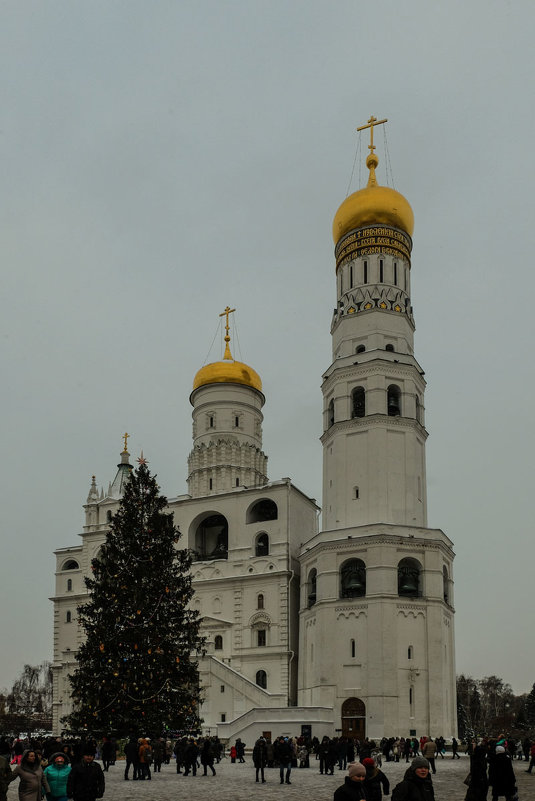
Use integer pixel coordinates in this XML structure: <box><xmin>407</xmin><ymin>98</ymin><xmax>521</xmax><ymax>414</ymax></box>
<box><xmin>52</xmin><ymin>118</ymin><xmax>457</xmax><ymax>742</ymax></box>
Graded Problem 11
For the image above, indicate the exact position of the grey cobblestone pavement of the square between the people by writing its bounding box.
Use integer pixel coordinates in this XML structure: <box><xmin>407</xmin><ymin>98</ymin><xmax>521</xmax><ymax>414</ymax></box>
<box><xmin>8</xmin><ymin>754</ymin><xmax>535</xmax><ymax>801</ymax></box>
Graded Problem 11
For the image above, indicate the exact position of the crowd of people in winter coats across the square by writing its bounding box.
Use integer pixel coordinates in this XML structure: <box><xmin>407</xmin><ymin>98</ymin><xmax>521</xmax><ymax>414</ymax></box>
<box><xmin>0</xmin><ymin>735</ymin><xmax>535</xmax><ymax>801</ymax></box>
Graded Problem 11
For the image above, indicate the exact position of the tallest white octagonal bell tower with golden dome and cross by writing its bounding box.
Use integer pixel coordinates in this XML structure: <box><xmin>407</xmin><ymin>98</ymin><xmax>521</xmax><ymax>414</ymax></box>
<box><xmin>299</xmin><ymin>117</ymin><xmax>456</xmax><ymax>738</ymax></box>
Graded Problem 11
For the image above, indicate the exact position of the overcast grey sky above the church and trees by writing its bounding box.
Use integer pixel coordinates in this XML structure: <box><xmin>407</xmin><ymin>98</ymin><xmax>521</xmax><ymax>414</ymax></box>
<box><xmin>0</xmin><ymin>0</ymin><xmax>535</xmax><ymax>692</ymax></box>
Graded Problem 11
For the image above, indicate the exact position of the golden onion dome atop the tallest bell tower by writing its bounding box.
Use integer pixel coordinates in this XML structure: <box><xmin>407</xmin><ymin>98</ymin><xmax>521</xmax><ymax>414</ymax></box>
<box><xmin>333</xmin><ymin>153</ymin><xmax>414</xmax><ymax>244</ymax></box>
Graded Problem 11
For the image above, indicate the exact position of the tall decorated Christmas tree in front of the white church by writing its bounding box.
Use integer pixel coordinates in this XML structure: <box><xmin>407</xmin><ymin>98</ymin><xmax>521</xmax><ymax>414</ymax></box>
<box><xmin>64</xmin><ymin>456</ymin><xmax>203</xmax><ymax>736</ymax></box>
